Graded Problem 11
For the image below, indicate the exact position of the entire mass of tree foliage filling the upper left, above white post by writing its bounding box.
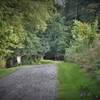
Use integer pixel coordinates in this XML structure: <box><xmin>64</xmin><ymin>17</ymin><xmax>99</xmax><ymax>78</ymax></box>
<box><xmin>0</xmin><ymin>0</ymin><xmax>56</xmax><ymax>67</ymax></box>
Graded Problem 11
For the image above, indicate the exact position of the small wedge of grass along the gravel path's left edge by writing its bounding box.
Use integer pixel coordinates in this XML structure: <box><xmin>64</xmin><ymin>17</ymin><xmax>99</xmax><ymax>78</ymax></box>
<box><xmin>0</xmin><ymin>67</ymin><xmax>16</xmax><ymax>78</ymax></box>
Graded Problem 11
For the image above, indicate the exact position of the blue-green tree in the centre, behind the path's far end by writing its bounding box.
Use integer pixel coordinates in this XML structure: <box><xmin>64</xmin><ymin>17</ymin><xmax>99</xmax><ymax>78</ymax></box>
<box><xmin>45</xmin><ymin>16</ymin><xmax>72</xmax><ymax>59</ymax></box>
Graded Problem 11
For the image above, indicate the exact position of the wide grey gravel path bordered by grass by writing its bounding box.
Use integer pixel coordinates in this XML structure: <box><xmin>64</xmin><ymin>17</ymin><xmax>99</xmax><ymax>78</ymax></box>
<box><xmin>0</xmin><ymin>64</ymin><xmax>57</xmax><ymax>100</ymax></box>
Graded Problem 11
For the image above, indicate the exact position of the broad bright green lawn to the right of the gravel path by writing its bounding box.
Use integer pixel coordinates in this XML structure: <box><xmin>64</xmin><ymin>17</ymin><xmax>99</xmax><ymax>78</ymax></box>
<box><xmin>57</xmin><ymin>62</ymin><xmax>100</xmax><ymax>100</ymax></box>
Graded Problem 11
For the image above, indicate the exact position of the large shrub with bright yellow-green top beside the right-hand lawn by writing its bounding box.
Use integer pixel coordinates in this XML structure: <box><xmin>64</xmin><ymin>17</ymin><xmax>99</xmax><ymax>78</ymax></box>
<box><xmin>65</xmin><ymin>21</ymin><xmax>100</xmax><ymax>68</ymax></box>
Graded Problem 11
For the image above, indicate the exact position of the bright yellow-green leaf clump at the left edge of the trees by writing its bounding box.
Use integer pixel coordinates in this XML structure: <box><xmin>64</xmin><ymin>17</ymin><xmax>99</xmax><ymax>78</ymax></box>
<box><xmin>0</xmin><ymin>21</ymin><xmax>23</xmax><ymax>57</ymax></box>
